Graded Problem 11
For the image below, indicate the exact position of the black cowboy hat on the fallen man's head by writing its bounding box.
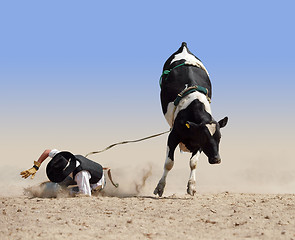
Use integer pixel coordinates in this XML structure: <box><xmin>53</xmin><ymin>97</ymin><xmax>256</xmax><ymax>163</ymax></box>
<box><xmin>46</xmin><ymin>152</ymin><xmax>76</xmax><ymax>183</ymax></box>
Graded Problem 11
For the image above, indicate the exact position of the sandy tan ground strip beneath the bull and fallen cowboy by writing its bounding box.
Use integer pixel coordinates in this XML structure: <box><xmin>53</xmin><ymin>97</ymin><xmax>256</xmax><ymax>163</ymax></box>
<box><xmin>0</xmin><ymin>186</ymin><xmax>295</xmax><ymax>240</ymax></box>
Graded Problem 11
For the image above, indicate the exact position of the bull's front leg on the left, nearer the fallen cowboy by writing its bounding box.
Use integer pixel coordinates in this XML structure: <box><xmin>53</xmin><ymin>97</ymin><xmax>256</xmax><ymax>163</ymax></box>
<box><xmin>154</xmin><ymin>130</ymin><xmax>179</xmax><ymax>197</ymax></box>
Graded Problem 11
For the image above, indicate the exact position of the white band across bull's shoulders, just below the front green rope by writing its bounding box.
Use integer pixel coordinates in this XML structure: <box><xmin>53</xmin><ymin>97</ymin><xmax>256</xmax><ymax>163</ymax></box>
<box><xmin>165</xmin><ymin>92</ymin><xmax>211</xmax><ymax>127</ymax></box>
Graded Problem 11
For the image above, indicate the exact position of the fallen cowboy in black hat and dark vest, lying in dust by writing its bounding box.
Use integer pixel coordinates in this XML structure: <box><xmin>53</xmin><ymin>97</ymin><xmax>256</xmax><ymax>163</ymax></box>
<box><xmin>20</xmin><ymin>149</ymin><xmax>118</xmax><ymax>196</ymax></box>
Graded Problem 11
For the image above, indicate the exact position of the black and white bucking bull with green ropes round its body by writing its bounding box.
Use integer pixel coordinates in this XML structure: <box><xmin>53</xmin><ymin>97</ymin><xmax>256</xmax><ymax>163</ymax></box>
<box><xmin>154</xmin><ymin>43</ymin><xmax>228</xmax><ymax>197</ymax></box>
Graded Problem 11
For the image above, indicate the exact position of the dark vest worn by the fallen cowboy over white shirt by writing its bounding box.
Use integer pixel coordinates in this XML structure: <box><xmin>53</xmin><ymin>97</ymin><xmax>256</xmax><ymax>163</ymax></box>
<box><xmin>73</xmin><ymin>155</ymin><xmax>103</xmax><ymax>184</ymax></box>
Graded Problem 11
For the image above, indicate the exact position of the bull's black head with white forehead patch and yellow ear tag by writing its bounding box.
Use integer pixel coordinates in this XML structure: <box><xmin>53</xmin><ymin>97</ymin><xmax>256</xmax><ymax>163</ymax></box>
<box><xmin>185</xmin><ymin>117</ymin><xmax>228</xmax><ymax>164</ymax></box>
